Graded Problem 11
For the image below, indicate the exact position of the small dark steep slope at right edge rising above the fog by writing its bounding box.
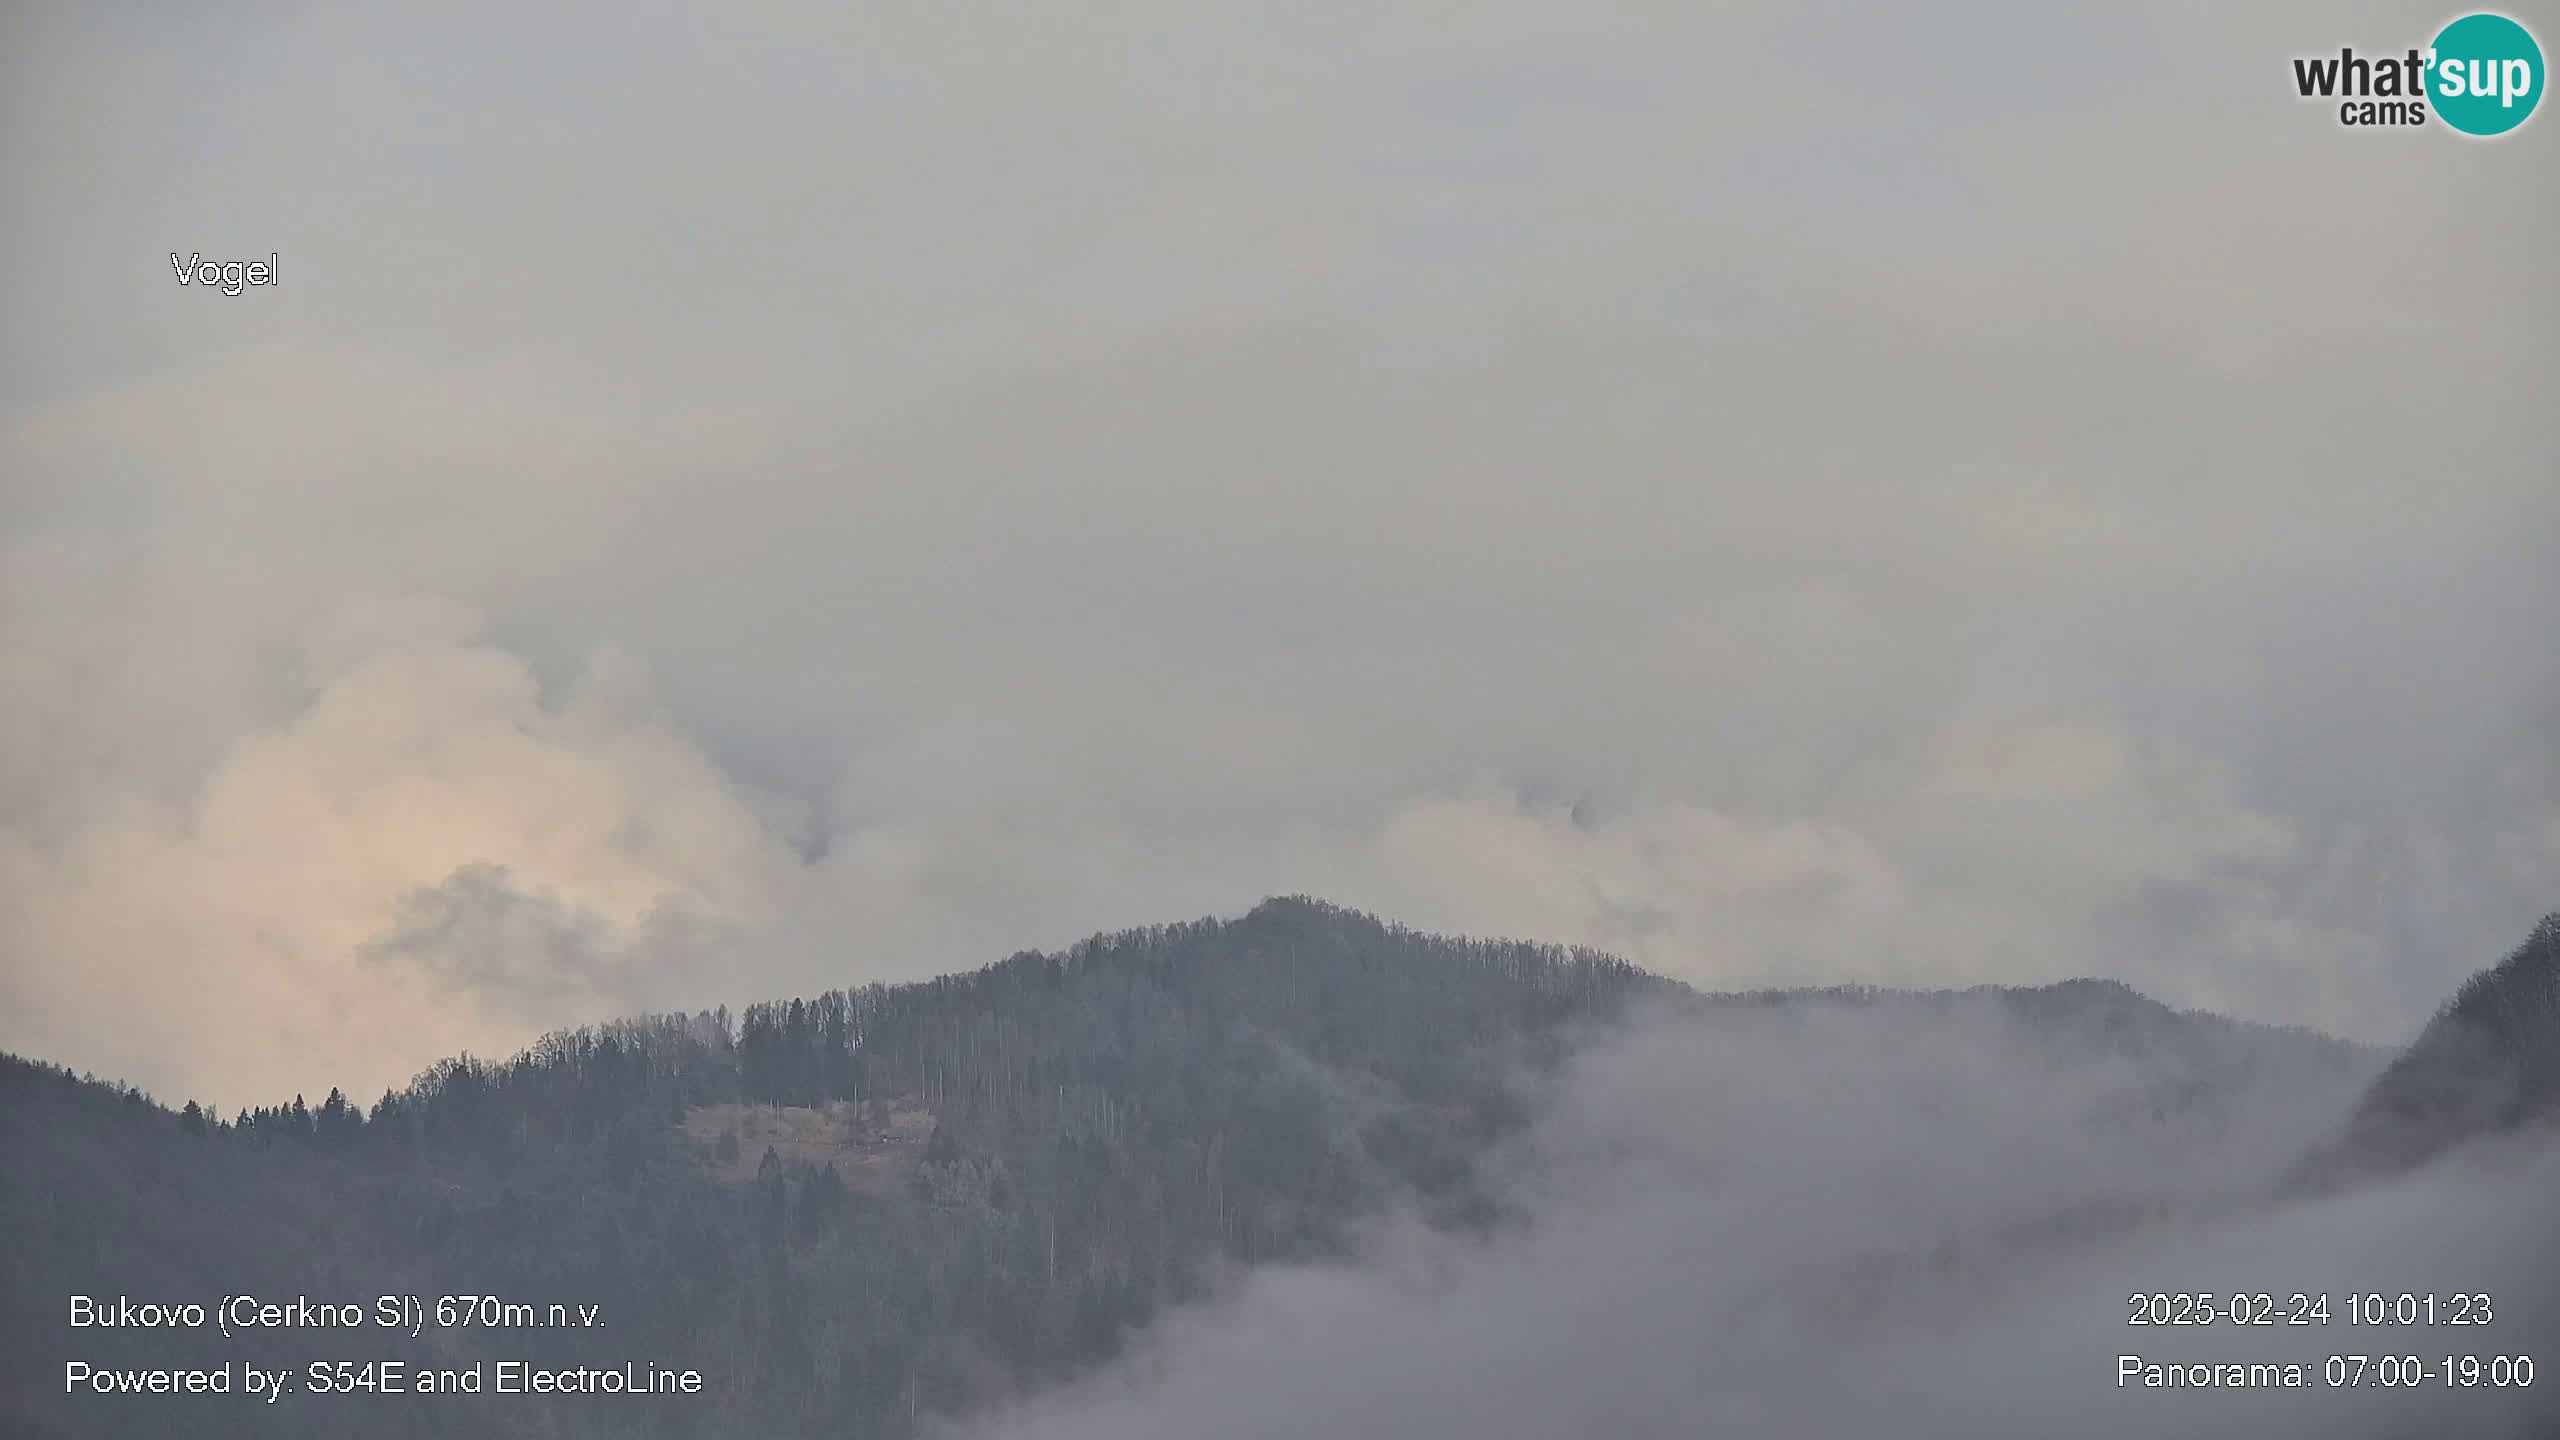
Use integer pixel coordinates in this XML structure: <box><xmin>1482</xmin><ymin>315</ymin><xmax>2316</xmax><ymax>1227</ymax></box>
<box><xmin>2307</xmin><ymin>912</ymin><xmax>2560</xmax><ymax>1181</ymax></box>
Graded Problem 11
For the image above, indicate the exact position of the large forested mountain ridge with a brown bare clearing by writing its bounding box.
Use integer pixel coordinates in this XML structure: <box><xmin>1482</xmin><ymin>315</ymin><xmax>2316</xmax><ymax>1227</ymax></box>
<box><xmin>0</xmin><ymin>899</ymin><xmax>2378</xmax><ymax>1437</ymax></box>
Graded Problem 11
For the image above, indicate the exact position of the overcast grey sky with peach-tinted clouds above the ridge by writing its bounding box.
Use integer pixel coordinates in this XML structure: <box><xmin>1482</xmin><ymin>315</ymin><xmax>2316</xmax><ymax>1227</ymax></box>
<box><xmin>0</xmin><ymin>3</ymin><xmax>2560</xmax><ymax>1104</ymax></box>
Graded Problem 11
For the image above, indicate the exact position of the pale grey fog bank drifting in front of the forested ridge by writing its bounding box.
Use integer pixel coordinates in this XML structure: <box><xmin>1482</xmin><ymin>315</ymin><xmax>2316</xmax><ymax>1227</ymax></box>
<box><xmin>970</xmin><ymin>1007</ymin><xmax>2560</xmax><ymax>1440</ymax></box>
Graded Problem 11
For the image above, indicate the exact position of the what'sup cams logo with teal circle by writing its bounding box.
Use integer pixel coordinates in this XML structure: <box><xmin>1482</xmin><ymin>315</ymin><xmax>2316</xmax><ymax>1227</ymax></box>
<box><xmin>2294</xmin><ymin>13</ymin><xmax>2542</xmax><ymax>138</ymax></box>
